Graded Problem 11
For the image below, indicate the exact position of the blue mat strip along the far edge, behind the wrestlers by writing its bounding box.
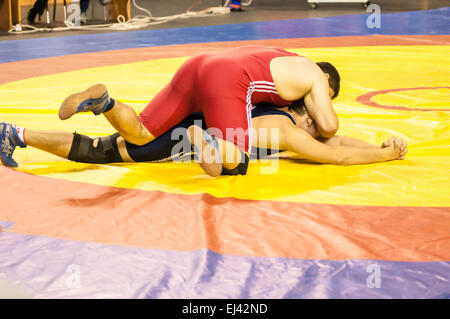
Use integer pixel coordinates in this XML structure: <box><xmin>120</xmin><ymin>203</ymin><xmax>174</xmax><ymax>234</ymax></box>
<box><xmin>0</xmin><ymin>8</ymin><xmax>450</xmax><ymax>63</ymax></box>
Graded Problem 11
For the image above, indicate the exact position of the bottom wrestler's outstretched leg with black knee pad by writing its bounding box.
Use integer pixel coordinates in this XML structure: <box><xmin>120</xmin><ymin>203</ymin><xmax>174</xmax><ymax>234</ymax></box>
<box><xmin>0</xmin><ymin>113</ymin><xmax>206</xmax><ymax>166</ymax></box>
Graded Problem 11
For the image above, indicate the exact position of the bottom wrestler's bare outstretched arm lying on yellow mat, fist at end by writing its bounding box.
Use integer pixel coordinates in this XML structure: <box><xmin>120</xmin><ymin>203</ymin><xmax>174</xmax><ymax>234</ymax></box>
<box><xmin>280</xmin><ymin>122</ymin><xmax>407</xmax><ymax>165</ymax></box>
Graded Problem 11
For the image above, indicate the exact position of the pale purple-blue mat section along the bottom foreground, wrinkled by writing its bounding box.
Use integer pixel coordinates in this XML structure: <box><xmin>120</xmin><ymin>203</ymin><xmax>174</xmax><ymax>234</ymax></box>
<box><xmin>0</xmin><ymin>232</ymin><xmax>450</xmax><ymax>299</ymax></box>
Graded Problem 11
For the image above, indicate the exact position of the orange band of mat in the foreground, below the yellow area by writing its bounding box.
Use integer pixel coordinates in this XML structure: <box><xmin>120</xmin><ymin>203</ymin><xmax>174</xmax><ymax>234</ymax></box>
<box><xmin>0</xmin><ymin>168</ymin><xmax>450</xmax><ymax>262</ymax></box>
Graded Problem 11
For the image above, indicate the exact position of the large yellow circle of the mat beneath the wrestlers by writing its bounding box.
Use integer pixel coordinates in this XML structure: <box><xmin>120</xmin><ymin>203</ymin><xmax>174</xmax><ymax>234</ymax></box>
<box><xmin>0</xmin><ymin>46</ymin><xmax>450</xmax><ymax>207</ymax></box>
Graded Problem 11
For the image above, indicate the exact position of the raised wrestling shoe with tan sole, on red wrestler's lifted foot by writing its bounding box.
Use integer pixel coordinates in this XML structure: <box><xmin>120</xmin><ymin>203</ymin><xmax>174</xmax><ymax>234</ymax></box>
<box><xmin>58</xmin><ymin>84</ymin><xmax>114</xmax><ymax>120</ymax></box>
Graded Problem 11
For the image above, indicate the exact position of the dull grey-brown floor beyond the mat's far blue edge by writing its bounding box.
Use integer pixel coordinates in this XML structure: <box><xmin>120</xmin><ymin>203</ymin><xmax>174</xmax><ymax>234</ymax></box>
<box><xmin>0</xmin><ymin>0</ymin><xmax>449</xmax><ymax>41</ymax></box>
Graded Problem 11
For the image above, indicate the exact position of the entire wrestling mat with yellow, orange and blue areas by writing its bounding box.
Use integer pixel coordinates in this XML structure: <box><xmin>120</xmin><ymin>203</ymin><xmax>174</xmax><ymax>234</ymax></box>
<box><xmin>0</xmin><ymin>8</ymin><xmax>450</xmax><ymax>298</ymax></box>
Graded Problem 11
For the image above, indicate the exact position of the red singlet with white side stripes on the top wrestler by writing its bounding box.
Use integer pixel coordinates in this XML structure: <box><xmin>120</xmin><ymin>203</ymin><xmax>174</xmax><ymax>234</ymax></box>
<box><xmin>139</xmin><ymin>46</ymin><xmax>296</xmax><ymax>152</ymax></box>
